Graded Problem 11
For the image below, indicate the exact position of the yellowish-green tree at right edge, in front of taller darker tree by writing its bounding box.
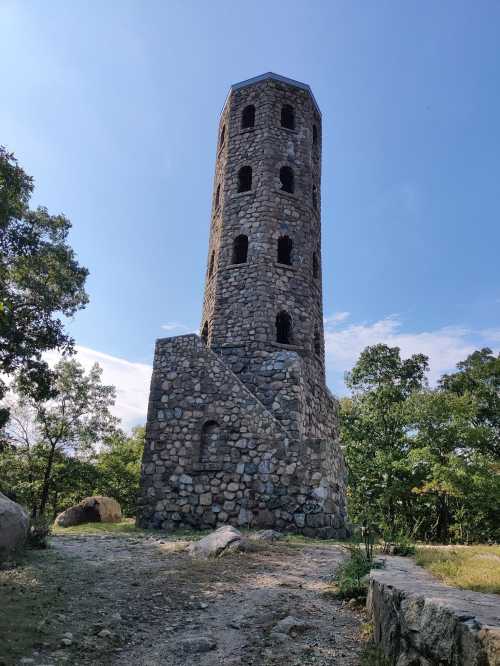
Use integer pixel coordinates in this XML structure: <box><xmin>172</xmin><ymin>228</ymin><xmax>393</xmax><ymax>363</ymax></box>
<box><xmin>407</xmin><ymin>389</ymin><xmax>500</xmax><ymax>543</ymax></box>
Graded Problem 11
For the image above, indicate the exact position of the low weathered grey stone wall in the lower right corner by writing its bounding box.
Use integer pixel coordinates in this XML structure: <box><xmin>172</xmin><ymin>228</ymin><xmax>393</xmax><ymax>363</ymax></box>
<box><xmin>367</xmin><ymin>557</ymin><xmax>500</xmax><ymax>666</ymax></box>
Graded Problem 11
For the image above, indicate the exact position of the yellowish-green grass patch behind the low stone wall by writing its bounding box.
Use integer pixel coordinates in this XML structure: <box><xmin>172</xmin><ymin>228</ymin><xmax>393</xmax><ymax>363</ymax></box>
<box><xmin>415</xmin><ymin>546</ymin><xmax>500</xmax><ymax>594</ymax></box>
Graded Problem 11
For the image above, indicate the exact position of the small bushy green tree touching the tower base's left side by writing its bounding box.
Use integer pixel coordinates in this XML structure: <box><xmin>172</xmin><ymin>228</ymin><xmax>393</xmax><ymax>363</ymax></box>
<box><xmin>96</xmin><ymin>426</ymin><xmax>144</xmax><ymax>516</ymax></box>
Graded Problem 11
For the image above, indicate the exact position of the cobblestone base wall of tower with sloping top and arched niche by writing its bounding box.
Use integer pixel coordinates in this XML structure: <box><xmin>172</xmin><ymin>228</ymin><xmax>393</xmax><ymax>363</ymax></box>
<box><xmin>138</xmin><ymin>335</ymin><xmax>346</xmax><ymax>538</ymax></box>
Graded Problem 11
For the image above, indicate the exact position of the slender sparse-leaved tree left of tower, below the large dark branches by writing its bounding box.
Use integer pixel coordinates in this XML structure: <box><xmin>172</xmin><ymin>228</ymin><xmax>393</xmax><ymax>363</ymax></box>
<box><xmin>6</xmin><ymin>359</ymin><xmax>118</xmax><ymax>516</ymax></box>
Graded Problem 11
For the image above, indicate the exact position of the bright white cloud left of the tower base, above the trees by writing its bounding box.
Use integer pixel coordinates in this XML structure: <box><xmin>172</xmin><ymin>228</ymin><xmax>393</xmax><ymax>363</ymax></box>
<box><xmin>46</xmin><ymin>345</ymin><xmax>152</xmax><ymax>430</ymax></box>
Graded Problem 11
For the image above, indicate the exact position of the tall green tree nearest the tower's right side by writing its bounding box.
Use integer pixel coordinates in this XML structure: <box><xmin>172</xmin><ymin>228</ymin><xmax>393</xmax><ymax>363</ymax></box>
<box><xmin>341</xmin><ymin>344</ymin><xmax>428</xmax><ymax>537</ymax></box>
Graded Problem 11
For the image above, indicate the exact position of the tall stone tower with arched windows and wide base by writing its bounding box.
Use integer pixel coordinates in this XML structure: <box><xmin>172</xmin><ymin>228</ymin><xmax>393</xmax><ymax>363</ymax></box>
<box><xmin>138</xmin><ymin>73</ymin><xmax>346</xmax><ymax>537</ymax></box>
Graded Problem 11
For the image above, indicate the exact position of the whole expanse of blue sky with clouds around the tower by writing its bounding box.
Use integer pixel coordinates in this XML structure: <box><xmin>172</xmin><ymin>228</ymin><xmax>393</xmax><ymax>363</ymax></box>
<box><xmin>0</xmin><ymin>0</ymin><xmax>500</xmax><ymax>422</ymax></box>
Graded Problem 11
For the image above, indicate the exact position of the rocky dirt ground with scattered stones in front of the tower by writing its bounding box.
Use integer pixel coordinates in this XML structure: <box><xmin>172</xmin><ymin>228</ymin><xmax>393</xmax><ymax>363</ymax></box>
<box><xmin>0</xmin><ymin>534</ymin><xmax>364</xmax><ymax>666</ymax></box>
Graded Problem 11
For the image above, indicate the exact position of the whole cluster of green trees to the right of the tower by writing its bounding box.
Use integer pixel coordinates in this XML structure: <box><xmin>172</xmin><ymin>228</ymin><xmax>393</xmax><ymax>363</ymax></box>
<box><xmin>341</xmin><ymin>345</ymin><xmax>500</xmax><ymax>544</ymax></box>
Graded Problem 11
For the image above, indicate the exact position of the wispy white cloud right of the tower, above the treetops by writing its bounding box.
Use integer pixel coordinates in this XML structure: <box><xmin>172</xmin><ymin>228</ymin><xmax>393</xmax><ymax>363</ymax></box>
<box><xmin>325</xmin><ymin>313</ymin><xmax>500</xmax><ymax>392</ymax></box>
